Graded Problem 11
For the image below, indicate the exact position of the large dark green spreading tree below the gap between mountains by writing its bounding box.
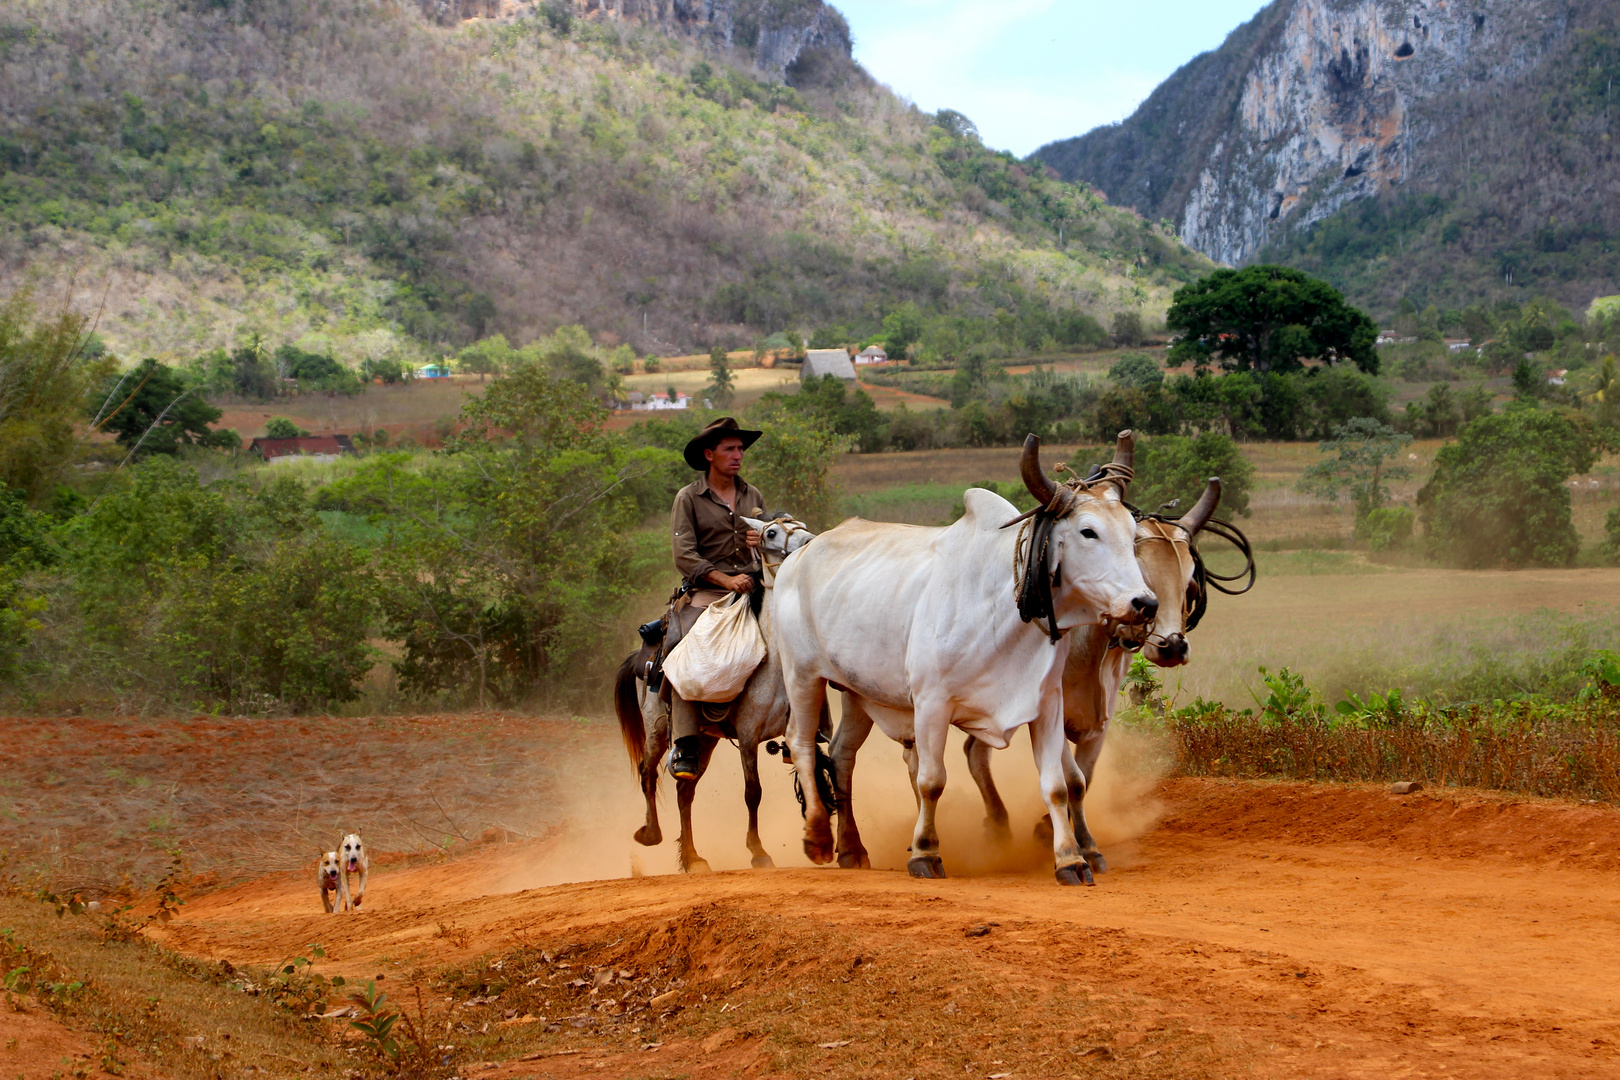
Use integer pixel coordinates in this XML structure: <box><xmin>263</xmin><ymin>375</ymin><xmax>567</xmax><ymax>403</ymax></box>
<box><xmin>1166</xmin><ymin>266</ymin><xmax>1379</xmax><ymax>374</ymax></box>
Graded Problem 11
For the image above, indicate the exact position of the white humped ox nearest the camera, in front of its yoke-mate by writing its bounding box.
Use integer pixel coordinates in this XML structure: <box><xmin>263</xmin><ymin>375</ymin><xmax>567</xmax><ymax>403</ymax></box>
<box><xmin>774</xmin><ymin>436</ymin><xmax>1158</xmax><ymax>884</ymax></box>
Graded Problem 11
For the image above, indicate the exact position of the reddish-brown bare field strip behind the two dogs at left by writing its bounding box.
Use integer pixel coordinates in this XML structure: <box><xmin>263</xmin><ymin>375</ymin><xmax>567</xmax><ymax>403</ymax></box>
<box><xmin>0</xmin><ymin>714</ymin><xmax>619</xmax><ymax>897</ymax></box>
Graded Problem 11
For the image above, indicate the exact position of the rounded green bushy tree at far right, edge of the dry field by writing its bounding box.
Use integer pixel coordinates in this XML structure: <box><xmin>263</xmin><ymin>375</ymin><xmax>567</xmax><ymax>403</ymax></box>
<box><xmin>1418</xmin><ymin>406</ymin><xmax>1592</xmax><ymax>568</ymax></box>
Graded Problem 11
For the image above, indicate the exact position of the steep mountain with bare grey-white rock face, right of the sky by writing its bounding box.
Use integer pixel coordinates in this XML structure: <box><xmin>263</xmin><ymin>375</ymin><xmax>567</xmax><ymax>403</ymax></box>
<box><xmin>1037</xmin><ymin>0</ymin><xmax>1620</xmax><ymax>308</ymax></box>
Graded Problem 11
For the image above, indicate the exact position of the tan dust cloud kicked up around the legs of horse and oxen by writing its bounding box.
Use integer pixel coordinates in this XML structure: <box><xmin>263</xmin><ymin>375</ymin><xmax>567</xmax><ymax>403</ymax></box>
<box><xmin>484</xmin><ymin>695</ymin><xmax>1168</xmax><ymax>892</ymax></box>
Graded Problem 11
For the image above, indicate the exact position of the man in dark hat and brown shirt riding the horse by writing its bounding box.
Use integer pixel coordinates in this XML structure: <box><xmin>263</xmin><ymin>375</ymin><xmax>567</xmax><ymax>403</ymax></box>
<box><xmin>664</xmin><ymin>416</ymin><xmax>765</xmax><ymax>780</ymax></box>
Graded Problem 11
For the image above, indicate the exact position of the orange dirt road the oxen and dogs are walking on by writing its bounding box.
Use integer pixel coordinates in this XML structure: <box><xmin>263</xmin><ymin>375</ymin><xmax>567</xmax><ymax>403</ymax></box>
<box><xmin>157</xmin><ymin>779</ymin><xmax>1620</xmax><ymax>1078</ymax></box>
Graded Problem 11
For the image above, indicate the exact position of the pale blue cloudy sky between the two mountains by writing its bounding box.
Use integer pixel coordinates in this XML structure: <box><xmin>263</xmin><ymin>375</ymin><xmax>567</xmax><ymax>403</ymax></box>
<box><xmin>833</xmin><ymin>0</ymin><xmax>1264</xmax><ymax>157</ymax></box>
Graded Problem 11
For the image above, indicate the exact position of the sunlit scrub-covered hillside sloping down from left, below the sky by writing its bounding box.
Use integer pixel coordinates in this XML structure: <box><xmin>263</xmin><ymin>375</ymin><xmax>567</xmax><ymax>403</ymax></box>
<box><xmin>0</xmin><ymin>0</ymin><xmax>1209</xmax><ymax>364</ymax></box>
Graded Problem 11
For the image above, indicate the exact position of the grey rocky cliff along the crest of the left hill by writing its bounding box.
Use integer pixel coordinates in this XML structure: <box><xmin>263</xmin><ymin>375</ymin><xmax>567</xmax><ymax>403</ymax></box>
<box><xmin>420</xmin><ymin>0</ymin><xmax>852</xmax><ymax>81</ymax></box>
